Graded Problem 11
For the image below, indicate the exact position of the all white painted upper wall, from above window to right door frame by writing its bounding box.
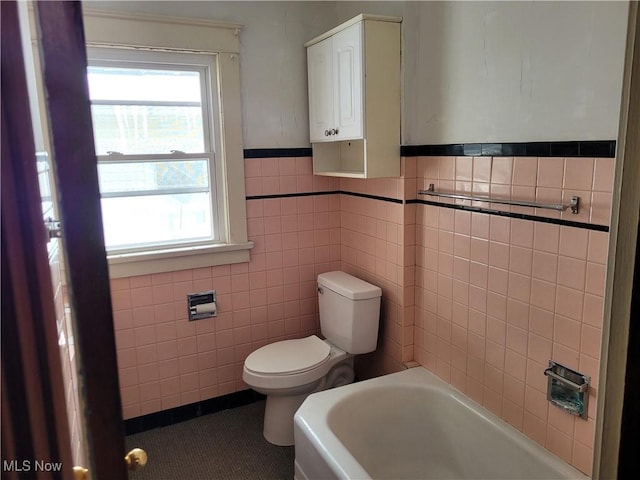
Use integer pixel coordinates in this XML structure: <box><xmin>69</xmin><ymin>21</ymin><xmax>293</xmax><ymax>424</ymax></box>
<box><xmin>85</xmin><ymin>1</ymin><xmax>628</xmax><ymax>148</ymax></box>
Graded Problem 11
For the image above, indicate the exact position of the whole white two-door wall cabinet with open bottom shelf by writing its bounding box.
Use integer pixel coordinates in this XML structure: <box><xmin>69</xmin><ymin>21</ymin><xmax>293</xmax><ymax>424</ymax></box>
<box><xmin>305</xmin><ymin>15</ymin><xmax>401</xmax><ymax>178</ymax></box>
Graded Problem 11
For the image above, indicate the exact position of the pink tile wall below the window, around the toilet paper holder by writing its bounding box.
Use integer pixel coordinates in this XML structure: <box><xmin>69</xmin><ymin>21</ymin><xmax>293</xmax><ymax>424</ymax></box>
<box><xmin>111</xmin><ymin>158</ymin><xmax>341</xmax><ymax>418</ymax></box>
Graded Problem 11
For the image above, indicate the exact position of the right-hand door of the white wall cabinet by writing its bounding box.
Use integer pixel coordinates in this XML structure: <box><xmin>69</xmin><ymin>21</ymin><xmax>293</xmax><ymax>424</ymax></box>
<box><xmin>332</xmin><ymin>22</ymin><xmax>363</xmax><ymax>140</ymax></box>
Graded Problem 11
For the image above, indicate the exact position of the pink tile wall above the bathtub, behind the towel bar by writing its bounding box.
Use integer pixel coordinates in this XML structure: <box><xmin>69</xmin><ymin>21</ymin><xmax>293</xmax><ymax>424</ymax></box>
<box><xmin>414</xmin><ymin>157</ymin><xmax>614</xmax><ymax>474</ymax></box>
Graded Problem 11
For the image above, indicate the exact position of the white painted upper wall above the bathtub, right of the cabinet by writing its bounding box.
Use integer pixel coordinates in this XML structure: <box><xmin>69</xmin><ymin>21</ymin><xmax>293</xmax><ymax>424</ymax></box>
<box><xmin>338</xmin><ymin>1</ymin><xmax>628</xmax><ymax>145</ymax></box>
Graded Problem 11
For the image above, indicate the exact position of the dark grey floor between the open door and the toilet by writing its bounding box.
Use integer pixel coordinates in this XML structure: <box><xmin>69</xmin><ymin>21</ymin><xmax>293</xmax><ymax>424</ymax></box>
<box><xmin>126</xmin><ymin>401</ymin><xmax>294</xmax><ymax>480</ymax></box>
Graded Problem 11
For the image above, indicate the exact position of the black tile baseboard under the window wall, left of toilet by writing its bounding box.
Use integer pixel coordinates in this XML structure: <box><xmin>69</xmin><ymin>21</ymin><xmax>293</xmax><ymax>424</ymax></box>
<box><xmin>124</xmin><ymin>390</ymin><xmax>266</xmax><ymax>435</ymax></box>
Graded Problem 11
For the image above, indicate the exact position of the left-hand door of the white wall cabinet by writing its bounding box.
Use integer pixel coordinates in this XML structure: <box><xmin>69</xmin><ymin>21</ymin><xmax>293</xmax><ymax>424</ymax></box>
<box><xmin>307</xmin><ymin>38</ymin><xmax>335</xmax><ymax>142</ymax></box>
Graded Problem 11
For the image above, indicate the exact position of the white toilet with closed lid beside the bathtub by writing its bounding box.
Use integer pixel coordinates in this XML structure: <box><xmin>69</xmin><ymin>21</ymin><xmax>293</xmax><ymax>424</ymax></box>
<box><xmin>242</xmin><ymin>271</ymin><xmax>382</xmax><ymax>446</ymax></box>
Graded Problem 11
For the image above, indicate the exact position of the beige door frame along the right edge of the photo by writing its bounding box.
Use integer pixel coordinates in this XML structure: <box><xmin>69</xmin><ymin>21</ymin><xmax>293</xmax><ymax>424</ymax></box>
<box><xmin>593</xmin><ymin>1</ymin><xmax>640</xmax><ymax>479</ymax></box>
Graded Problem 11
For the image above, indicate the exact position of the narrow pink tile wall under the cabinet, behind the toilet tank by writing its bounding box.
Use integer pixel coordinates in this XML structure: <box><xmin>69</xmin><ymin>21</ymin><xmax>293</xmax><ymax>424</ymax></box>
<box><xmin>340</xmin><ymin>160</ymin><xmax>415</xmax><ymax>378</ymax></box>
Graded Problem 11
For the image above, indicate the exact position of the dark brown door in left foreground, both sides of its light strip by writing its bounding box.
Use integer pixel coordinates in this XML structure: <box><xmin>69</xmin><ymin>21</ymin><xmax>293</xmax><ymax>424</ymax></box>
<box><xmin>1</xmin><ymin>2</ymin><xmax>132</xmax><ymax>480</ymax></box>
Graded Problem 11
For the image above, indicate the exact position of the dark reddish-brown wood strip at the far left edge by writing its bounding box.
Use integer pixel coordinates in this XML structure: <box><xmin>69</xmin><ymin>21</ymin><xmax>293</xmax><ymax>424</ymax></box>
<box><xmin>0</xmin><ymin>2</ymin><xmax>71</xmax><ymax>479</ymax></box>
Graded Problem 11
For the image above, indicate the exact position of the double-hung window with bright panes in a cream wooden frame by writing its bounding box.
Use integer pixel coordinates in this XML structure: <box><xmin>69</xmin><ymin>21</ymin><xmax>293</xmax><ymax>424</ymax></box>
<box><xmin>87</xmin><ymin>49</ymin><xmax>225</xmax><ymax>252</ymax></box>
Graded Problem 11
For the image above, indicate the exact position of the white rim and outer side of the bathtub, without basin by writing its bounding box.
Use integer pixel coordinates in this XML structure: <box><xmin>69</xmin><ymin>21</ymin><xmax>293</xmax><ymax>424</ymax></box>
<box><xmin>294</xmin><ymin>366</ymin><xmax>589</xmax><ymax>480</ymax></box>
